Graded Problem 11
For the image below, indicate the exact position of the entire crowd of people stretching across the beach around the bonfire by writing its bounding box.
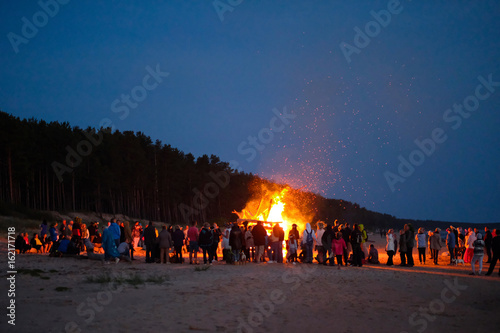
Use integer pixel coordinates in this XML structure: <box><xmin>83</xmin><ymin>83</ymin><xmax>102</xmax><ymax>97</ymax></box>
<box><xmin>15</xmin><ymin>217</ymin><xmax>500</xmax><ymax>275</ymax></box>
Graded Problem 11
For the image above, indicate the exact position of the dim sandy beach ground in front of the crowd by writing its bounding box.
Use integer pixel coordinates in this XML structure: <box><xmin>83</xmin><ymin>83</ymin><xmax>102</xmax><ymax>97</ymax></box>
<box><xmin>0</xmin><ymin>236</ymin><xmax>500</xmax><ymax>332</ymax></box>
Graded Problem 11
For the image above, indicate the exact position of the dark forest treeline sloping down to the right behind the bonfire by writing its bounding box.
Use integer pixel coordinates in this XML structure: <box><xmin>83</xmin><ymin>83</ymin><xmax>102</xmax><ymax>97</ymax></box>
<box><xmin>0</xmin><ymin>111</ymin><xmax>500</xmax><ymax>228</ymax></box>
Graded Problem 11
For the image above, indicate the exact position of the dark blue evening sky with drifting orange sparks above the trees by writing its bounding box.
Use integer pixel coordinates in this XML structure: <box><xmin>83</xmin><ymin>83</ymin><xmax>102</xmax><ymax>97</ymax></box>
<box><xmin>0</xmin><ymin>0</ymin><xmax>500</xmax><ymax>223</ymax></box>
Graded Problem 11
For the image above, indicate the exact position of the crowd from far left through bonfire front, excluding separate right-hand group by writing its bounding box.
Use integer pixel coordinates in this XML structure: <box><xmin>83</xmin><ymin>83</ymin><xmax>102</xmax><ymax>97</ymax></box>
<box><xmin>12</xmin><ymin>217</ymin><xmax>372</xmax><ymax>267</ymax></box>
